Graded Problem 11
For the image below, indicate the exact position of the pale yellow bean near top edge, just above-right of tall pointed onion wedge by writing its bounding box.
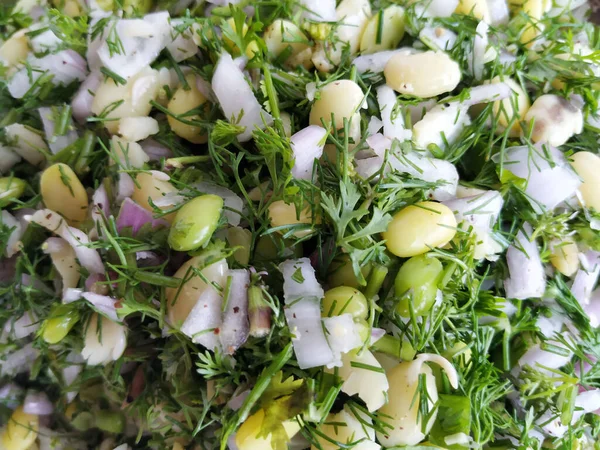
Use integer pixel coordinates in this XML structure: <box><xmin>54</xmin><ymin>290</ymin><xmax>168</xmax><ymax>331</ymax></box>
<box><xmin>263</xmin><ymin>19</ymin><xmax>313</xmax><ymax>69</ymax></box>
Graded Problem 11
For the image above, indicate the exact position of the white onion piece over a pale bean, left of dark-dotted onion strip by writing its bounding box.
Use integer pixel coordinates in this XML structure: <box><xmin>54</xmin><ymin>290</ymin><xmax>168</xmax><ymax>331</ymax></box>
<box><xmin>181</xmin><ymin>289</ymin><xmax>223</xmax><ymax>350</ymax></box>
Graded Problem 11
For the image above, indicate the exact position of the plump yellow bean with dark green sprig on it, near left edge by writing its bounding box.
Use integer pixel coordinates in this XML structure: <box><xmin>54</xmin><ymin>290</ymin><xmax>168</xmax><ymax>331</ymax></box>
<box><xmin>40</xmin><ymin>163</ymin><xmax>88</xmax><ymax>227</ymax></box>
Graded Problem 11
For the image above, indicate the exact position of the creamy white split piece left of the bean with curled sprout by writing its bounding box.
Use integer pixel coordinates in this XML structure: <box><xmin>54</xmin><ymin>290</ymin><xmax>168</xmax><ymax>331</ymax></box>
<box><xmin>337</xmin><ymin>350</ymin><xmax>389</xmax><ymax>412</ymax></box>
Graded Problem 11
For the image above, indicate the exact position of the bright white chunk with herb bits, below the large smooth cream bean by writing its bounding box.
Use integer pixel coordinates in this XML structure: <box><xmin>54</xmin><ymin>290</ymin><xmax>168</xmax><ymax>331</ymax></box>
<box><xmin>413</xmin><ymin>103</ymin><xmax>471</xmax><ymax>149</ymax></box>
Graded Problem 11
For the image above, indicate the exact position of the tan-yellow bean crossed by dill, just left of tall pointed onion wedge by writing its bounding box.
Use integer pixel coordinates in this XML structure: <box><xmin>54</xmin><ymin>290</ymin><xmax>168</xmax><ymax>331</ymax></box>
<box><xmin>167</xmin><ymin>73</ymin><xmax>209</xmax><ymax>144</ymax></box>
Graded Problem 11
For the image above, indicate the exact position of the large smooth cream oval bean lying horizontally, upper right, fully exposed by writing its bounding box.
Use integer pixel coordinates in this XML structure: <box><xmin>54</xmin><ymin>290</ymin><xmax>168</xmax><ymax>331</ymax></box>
<box><xmin>384</xmin><ymin>51</ymin><xmax>461</xmax><ymax>98</ymax></box>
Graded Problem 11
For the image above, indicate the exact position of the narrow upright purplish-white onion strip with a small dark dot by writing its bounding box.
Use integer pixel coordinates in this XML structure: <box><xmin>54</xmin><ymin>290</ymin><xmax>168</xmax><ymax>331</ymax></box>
<box><xmin>219</xmin><ymin>269</ymin><xmax>250</xmax><ymax>355</ymax></box>
